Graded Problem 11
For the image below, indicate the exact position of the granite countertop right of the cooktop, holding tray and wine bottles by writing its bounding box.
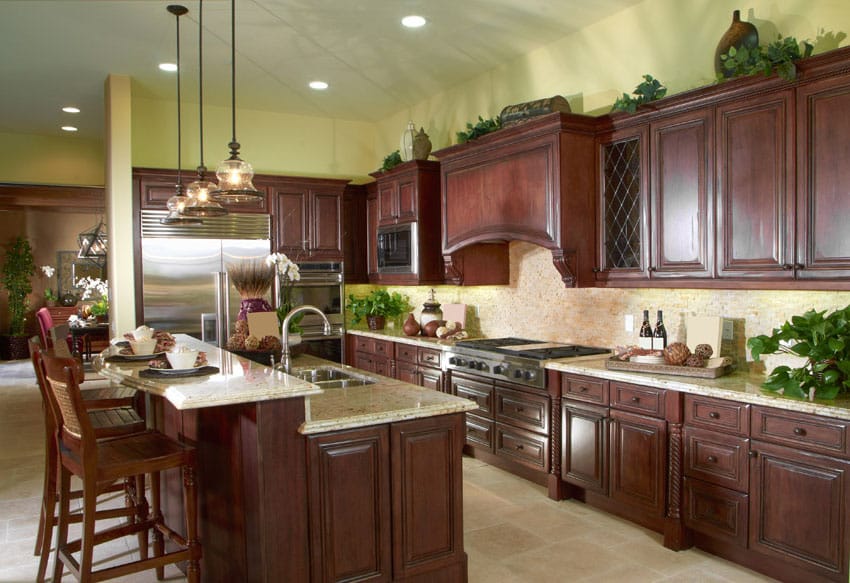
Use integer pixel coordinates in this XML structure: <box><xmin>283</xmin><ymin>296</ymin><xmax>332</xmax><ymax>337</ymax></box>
<box><xmin>545</xmin><ymin>358</ymin><xmax>850</xmax><ymax>419</ymax></box>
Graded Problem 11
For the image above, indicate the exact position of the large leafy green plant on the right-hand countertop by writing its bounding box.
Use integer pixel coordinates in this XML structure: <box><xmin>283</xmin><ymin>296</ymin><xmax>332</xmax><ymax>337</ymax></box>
<box><xmin>747</xmin><ymin>306</ymin><xmax>850</xmax><ymax>399</ymax></box>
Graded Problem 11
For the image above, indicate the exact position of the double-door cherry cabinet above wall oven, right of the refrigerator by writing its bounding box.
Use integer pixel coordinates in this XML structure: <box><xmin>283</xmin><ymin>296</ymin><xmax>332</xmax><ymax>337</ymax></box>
<box><xmin>270</xmin><ymin>179</ymin><xmax>347</xmax><ymax>261</ymax></box>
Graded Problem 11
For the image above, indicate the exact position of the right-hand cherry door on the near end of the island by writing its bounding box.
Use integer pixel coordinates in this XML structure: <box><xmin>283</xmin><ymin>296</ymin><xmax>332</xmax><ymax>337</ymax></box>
<box><xmin>390</xmin><ymin>414</ymin><xmax>466</xmax><ymax>581</ymax></box>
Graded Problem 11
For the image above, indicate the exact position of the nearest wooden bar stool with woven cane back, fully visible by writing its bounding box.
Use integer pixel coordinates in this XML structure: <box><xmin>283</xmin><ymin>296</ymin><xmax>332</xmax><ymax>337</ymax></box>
<box><xmin>42</xmin><ymin>354</ymin><xmax>201</xmax><ymax>583</ymax></box>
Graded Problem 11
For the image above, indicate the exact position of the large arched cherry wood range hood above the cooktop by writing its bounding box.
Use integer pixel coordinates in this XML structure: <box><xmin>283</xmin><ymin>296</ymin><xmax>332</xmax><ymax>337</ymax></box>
<box><xmin>434</xmin><ymin>112</ymin><xmax>597</xmax><ymax>287</ymax></box>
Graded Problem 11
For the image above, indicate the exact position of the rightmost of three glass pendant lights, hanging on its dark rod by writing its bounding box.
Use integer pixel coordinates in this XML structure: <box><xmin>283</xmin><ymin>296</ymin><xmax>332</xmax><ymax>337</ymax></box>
<box><xmin>210</xmin><ymin>0</ymin><xmax>263</xmax><ymax>204</ymax></box>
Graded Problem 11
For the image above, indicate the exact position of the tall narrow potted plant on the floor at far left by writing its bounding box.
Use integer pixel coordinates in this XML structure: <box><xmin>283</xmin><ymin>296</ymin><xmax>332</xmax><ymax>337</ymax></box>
<box><xmin>0</xmin><ymin>236</ymin><xmax>35</xmax><ymax>360</ymax></box>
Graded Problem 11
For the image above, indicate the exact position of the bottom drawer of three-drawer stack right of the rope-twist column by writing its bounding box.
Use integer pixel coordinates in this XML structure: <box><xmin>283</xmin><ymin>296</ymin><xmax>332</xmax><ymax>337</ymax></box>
<box><xmin>684</xmin><ymin>477</ymin><xmax>749</xmax><ymax>547</ymax></box>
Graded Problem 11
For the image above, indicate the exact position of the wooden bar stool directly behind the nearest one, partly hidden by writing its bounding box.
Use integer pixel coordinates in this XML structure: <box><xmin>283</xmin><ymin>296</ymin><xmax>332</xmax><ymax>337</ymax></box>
<box><xmin>29</xmin><ymin>336</ymin><xmax>147</xmax><ymax>583</ymax></box>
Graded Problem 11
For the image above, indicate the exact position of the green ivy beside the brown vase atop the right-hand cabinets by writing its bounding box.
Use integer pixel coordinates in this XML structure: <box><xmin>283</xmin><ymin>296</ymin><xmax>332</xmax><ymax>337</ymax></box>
<box><xmin>718</xmin><ymin>36</ymin><xmax>814</xmax><ymax>81</ymax></box>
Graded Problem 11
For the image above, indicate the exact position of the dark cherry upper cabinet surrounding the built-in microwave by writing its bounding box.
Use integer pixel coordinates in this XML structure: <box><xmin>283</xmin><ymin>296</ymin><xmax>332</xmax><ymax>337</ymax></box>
<box><xmin>367</xmin><ymin>160</ymin><xmax>444</xmax><ymax>285</ymax></box>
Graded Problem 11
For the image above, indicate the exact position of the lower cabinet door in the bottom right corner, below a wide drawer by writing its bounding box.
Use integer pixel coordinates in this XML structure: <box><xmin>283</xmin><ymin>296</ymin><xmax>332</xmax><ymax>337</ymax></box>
<box><xmin>750</xmin><ymin>441</ymin><xmax>850</xmax><ymax>581</ymax></box>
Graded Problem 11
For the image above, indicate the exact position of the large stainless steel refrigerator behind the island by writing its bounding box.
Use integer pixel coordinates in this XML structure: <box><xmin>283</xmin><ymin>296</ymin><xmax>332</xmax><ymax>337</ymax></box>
<box><xmin>142</xmin><ymin>211</ymin><xmax>271</xmax><ymax>344</ymax></box>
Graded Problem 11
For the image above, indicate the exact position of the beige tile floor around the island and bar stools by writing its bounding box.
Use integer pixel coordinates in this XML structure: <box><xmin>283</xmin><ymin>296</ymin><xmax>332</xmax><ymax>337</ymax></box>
<box><xmin>0</xmin><ymin>361</ymin><xmax>772</xmax><ymax>583</ymax></box>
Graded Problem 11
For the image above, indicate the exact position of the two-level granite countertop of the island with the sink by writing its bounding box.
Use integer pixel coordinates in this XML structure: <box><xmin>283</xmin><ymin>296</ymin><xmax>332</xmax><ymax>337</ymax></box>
<box><xmin>95</xmin><ymin>334</ymin><xmax>477</xmax><ymax>434</ymax></box>
